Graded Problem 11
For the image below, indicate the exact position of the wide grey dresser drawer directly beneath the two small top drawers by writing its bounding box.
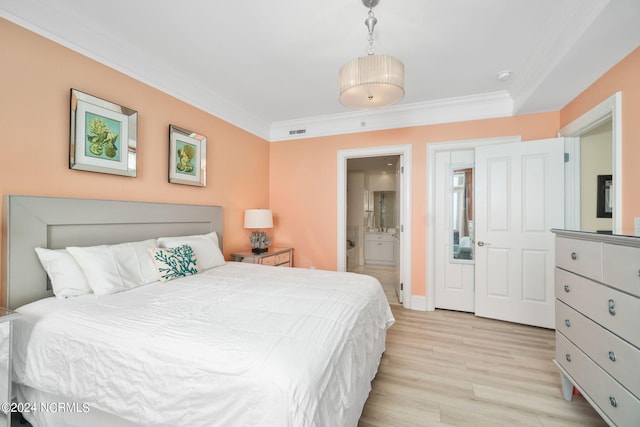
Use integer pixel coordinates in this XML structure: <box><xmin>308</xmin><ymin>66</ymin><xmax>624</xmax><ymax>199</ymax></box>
<box><xmin>555</xmin><ymin>268</ymin><xmax>640</xmax><ymax>347</ymax></box>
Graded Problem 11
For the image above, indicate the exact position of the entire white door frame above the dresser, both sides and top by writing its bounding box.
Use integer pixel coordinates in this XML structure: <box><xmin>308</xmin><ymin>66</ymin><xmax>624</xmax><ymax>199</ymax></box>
<box><xmin>558</xmin><ymin>92</ymin><xmax>623</xmax><ymax>234</ymax></box>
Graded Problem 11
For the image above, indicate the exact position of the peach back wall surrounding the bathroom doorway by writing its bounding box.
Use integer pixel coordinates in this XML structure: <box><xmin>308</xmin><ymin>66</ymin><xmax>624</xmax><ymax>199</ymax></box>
<box><xmin>270</xmin><ymin>112</ymin><xmax>559</xmax><ymax>295</ymax></box>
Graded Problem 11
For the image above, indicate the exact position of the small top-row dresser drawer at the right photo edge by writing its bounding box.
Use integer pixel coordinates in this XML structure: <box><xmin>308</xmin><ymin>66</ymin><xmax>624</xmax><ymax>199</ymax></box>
<box><xmin>603</xmin><ymin>243</ymin><xmax>640</xmax><ymax>297</ymax></box>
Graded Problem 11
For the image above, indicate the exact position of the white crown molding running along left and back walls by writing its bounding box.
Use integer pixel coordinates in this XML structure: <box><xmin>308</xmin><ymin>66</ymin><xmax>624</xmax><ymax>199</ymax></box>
<box><xmin>0</xmin><ymin>10</ymin><xmax>513</xmax><ymax>142</ymax></box>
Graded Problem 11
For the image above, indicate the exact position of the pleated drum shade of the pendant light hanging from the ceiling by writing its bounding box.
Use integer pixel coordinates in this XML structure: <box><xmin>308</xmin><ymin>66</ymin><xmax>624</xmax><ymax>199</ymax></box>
<box><xmin>339</xmin><ymin>55</ymin><xmax>404</xmax><ymax>109</ymax></box>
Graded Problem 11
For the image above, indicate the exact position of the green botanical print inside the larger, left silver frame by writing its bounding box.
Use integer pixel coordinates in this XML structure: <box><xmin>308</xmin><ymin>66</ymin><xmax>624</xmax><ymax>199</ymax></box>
<box><xmin>85</xmin><ymin>112</ymin><xmax>122</xmax><ymax>162</ymax></box>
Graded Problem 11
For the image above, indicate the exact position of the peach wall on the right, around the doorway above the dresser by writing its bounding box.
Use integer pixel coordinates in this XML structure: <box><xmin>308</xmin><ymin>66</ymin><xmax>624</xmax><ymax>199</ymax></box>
<box><xmin>560</xmin><ymin>48</ymin><xmax>640</xmax><ymax>235</ymax></box>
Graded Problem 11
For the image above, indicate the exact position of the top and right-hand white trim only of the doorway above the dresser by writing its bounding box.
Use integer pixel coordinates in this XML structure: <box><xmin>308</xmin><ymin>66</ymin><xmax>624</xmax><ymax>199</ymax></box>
<box><xmin>558</xmin><ymin>92</ymin><xmax>624</xmax><ymax>234</ymax></box>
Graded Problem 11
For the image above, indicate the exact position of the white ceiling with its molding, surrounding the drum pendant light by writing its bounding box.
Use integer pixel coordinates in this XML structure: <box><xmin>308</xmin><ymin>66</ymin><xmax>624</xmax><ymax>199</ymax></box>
<box><xmin>0</xmin><ymin>0</ymin><xmax>640</xmax><ymax>141</ymax></box>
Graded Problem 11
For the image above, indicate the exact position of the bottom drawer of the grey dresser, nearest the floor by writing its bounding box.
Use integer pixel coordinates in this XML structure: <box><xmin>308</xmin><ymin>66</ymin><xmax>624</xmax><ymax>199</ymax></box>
<box><xmin>556</xmin><ymin>334</ymin><xmax>640</xmax><ymax>426</ymax></box>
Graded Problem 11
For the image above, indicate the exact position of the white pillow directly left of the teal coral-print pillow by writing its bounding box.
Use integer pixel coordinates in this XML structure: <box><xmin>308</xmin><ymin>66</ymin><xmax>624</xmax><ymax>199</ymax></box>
<box><xmin>67</xmin><ymin>239</ymin><xmax>158</xmax><ymax>295</ymax></box>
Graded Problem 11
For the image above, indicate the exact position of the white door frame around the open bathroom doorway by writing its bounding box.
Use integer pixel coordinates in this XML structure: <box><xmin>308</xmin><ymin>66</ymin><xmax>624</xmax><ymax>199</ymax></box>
<box><xmin>336</xmin><ymin>144</ymin><xmax>412</xmax><ymax>308</ymax></box>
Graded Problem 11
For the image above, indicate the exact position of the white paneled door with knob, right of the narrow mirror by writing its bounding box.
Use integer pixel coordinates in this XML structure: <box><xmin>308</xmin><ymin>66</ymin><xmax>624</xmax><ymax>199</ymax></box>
<box><xmin>475</xmin><ymin>138</ymin><xmax>564</xmax><ymax>328</ymax></box>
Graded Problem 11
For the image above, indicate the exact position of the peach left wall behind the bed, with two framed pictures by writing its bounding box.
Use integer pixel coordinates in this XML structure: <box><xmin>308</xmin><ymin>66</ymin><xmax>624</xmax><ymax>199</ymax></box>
<box><xmin>0</xmin><ymin>18</ymin><xmax>269</xmax><ymax>300</ymax></box>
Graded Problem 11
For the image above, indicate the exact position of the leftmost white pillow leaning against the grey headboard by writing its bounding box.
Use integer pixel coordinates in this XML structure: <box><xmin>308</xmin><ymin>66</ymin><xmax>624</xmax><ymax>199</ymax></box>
<box><xmin>35</xmin><ymin>248</ymin><xmax>92</xmax><ymax>298</ymax></box>
